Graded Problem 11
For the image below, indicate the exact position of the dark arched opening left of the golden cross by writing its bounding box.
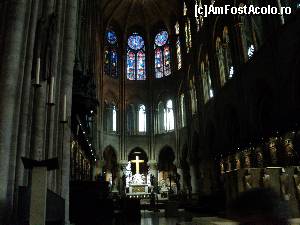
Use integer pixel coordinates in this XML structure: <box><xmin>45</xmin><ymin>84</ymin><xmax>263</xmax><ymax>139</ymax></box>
<box><xmin>102</xmin><ymin>145</ymin><xmax>118</xmax><ymax>185</ymax></box>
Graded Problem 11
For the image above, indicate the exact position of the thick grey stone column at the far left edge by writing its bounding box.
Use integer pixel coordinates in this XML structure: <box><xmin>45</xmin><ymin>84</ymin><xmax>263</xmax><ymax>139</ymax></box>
<box><xmin>0</xmin><ymin>0</ymin><xmax>28</xmax><ymax>224</ymax></box>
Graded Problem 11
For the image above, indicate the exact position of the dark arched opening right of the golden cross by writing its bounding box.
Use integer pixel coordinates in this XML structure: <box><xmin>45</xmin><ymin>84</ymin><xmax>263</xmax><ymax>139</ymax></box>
<box><xmin>158</xmin><ymin>146</ymin><xmax>177</xmax><ymax>192</ymax></box>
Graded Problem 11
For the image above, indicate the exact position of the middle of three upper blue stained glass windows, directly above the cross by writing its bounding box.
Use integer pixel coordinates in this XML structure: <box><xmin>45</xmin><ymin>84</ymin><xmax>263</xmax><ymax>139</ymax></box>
<box><xmin>127</xmin><ymin>33</ymin><xmax>146</xmax><ymax>80</ymax></box>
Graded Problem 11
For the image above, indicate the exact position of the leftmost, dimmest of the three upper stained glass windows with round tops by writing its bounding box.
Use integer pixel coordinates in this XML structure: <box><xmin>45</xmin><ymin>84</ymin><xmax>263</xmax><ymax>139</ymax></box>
<box><xmin>104</xmin><ymin>30</ymin><xmax>119</xmax><ymax>78</ymax></box>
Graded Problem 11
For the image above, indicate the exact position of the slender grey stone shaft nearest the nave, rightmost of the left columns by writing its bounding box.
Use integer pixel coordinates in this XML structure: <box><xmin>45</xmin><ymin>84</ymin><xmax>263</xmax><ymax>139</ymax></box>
<box><xmin>59</xmin><ymin>0</ymin><xmax>78</xmax><ymax>224</ymax></box>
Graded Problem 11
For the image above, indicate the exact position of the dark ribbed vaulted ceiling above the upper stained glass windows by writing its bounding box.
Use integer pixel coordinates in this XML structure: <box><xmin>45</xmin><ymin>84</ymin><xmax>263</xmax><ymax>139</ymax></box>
<box><xmin>101</xmin><ymin>0</ymin><xmax>182</xmax><ymax>32</ymax></box>
